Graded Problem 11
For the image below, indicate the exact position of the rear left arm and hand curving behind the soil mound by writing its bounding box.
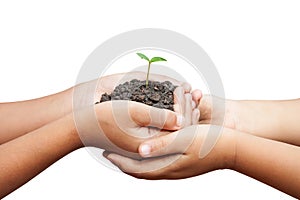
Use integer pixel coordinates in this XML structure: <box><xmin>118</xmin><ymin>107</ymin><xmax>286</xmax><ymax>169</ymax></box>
<box><xmin>0</xmin><ymin>72</ymin><xmax>191</xmax><ymax>144</ymax></box>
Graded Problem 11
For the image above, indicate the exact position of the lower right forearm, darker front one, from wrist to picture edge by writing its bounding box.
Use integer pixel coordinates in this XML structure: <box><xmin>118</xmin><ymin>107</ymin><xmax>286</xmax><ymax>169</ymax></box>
<box><xmin>234</xmin><ymin>130</ymin><xmax>300</xmax><ymax>198</ymax></box>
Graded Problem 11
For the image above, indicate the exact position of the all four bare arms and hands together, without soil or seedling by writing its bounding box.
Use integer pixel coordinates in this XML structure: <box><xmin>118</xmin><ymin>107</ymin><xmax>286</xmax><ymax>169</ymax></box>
<box><xmin>0</xmin><ymin>72</ymin><xmax>300</xmax><ymax>198</ymax></box>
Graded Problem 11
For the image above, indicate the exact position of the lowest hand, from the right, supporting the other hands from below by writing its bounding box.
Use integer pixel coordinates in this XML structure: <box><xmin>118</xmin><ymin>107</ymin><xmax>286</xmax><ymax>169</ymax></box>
<box><xmin>104</xmin><ymin>125</ymin><xmax>236</xmax><ymax>179</ymax></box>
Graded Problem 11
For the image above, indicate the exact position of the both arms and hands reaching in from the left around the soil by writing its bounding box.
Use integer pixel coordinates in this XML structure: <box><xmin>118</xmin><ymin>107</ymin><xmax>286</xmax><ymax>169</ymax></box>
<box><xmin>0</xmin><ymin>72</ymin><xmax>195</xmax><ymax>198</ymax></box>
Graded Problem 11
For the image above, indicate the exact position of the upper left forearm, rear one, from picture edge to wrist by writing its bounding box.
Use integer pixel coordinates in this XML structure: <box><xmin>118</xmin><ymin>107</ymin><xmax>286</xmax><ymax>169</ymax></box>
<box><xmin>0</xmin><ymin>89</ymin><xmax>72</xmax><ymax>144</ymax></box>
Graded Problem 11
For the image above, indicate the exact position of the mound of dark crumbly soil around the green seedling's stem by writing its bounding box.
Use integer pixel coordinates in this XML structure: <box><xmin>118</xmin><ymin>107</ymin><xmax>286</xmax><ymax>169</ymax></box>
<box><xmin>97</xmin><ymin>79</ymin><xmax>177</xmax><ymax>111</ymax></box>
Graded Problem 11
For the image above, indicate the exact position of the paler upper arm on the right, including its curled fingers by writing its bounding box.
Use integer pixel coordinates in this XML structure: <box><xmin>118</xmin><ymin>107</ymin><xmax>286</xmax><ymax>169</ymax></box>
<box><xmin>193</xmin><ymin>91</ymin><xmax>300</xmax><ymax>146</ymax></box>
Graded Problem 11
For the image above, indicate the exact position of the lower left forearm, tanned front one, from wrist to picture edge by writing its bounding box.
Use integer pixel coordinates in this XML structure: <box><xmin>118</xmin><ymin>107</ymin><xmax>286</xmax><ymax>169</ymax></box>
<box><xmin>0</xmin><ymin>116</ymin><xmax>82</xmax><ymax>198</ymax></box>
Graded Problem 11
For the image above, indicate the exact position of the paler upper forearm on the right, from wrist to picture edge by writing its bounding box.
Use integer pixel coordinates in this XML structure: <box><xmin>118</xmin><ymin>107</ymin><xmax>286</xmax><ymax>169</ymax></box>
<box><xmin>233</xmin><ymin>99</ymin><xmax>300</xmax><ymax>146</ymax></box>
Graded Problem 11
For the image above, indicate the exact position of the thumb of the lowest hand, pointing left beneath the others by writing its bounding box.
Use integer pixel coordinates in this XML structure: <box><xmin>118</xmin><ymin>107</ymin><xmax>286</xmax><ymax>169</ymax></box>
<box><xmin>139</xmin><ymin>126</ymin><xmax>197</xmax><ymax>157</ymax></box>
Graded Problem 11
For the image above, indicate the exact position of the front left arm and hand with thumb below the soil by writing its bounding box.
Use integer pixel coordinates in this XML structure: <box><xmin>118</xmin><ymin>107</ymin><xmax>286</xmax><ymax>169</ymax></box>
<box><xmin>0</xmin><ymin>97</ymin><xmax>184</xmax><ymax>199</ymax></box>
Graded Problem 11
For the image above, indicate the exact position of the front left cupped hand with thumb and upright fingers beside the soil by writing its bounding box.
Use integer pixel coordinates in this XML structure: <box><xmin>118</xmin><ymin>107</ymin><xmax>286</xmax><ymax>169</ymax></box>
<box><xmin>74</xmin><ymin>87</ymin><xmax>199</xmax><ymax>157</ymax></box>
